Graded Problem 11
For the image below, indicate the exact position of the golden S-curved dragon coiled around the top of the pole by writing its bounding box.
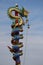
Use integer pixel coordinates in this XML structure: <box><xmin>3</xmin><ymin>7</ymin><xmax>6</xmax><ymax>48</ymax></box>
<box><xmin>8</xmin><ymin>7</ymin><xmax>28</xmax><ymax>27</ymax></box>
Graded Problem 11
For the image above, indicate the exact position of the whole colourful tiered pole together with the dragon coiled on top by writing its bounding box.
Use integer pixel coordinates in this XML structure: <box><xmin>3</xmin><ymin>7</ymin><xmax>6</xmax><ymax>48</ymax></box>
<box><xmin>8</xmin><ymin>4</ymin><xmax>29</xmax><ymax>65</ymax></box>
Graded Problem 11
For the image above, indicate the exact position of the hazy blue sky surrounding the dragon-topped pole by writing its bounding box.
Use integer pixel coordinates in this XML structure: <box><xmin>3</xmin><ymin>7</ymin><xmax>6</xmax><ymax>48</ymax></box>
<box><xmin>0</xmin><ymin>0</ymin><xmax>43</xmax><ymax>65</ymax></box>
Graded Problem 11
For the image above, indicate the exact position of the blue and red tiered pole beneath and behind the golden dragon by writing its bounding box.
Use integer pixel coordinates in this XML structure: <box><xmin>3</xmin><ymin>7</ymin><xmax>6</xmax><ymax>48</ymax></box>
<box><xmin>11</xmin><ymin>5</ymin><xmax>23</xmax><ymax>65</ymax></box>
